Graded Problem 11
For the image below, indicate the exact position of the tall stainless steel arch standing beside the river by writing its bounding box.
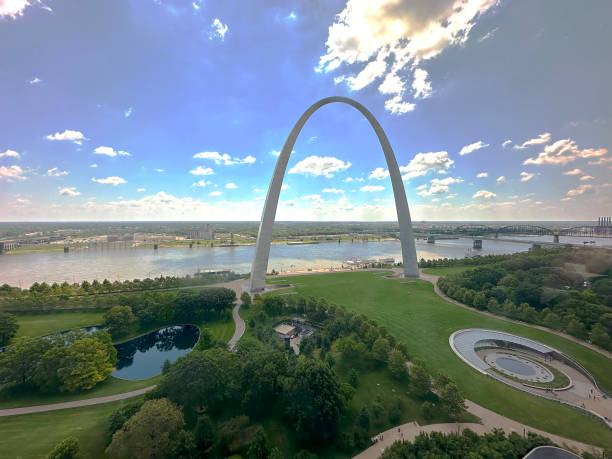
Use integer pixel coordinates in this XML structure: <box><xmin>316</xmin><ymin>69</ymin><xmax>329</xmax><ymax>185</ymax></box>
<box><xmin>249</xmin><ymin>97</ymin><xmax>419</xmax><ymax>292</ymax></box>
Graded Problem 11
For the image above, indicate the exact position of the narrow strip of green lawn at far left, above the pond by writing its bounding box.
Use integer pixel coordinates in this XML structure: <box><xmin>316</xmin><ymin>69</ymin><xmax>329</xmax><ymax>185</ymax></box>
<box><xmin>17</xmin><ymin>311</ymin><xmax>104</xmax><ymax>338</ymax></box>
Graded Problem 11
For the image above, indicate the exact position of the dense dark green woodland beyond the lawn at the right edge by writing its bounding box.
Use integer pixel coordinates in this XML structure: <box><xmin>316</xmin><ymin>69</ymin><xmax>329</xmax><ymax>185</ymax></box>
<box><xmin>438</xmin><ymin>249</ymin><xmax>612</xmax><ymax>350</ymax></box>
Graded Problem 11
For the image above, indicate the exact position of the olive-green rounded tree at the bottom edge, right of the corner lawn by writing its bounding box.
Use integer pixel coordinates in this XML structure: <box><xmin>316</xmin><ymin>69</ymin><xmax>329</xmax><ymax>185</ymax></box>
<box><xmin>106</xmin><ymin>398</ymin><xmax>185</xmax><ymax>459</ymax></box>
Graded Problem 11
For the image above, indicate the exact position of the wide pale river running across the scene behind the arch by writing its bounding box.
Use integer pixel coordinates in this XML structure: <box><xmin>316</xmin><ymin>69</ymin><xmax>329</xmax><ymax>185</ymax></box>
<box><xmin>0</xmin><ymin>236</ymin><xmax>612</xmax><ymax>287</ymax></box>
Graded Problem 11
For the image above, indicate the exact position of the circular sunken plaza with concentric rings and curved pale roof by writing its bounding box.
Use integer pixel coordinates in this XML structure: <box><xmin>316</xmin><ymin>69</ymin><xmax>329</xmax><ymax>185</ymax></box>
<box><xmin>449</xmin><ymin>328</ymin><xmax>612</xmax><ymax>427</ymax></box>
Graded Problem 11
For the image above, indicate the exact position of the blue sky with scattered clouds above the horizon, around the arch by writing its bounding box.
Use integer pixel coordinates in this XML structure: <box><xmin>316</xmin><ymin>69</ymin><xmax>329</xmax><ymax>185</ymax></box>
<box><xmin>0</xmin><ymin>0</ymin><xmax>612</xmax><ymax>221</ymax></box>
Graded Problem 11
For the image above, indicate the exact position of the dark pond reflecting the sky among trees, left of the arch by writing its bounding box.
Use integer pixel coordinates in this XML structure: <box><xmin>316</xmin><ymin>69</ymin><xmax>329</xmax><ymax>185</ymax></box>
<box><xmin>113</xmin><ymin>325</ymin><xmax>200</xmax><ymax>380</ymax></box>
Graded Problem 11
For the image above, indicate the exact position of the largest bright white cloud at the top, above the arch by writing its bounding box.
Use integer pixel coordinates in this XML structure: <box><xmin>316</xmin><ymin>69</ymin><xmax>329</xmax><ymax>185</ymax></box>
<box><xmin>315</xmin><ymin>0</ymin><xmax>497</xmax><ymax>115</ymax></box>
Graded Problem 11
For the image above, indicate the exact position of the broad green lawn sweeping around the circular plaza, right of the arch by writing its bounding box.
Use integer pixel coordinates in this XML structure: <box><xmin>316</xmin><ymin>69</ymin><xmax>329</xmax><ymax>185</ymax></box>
<box><xmin>272</xmin><ymin>272</ymin><xmax>612</xmax><ymax>448</ymax></box>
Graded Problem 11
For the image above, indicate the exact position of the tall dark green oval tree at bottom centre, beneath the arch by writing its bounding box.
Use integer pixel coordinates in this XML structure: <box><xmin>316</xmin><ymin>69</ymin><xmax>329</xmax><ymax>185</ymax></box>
<box><xmin>286</xmin><ymin>359</ymin><xmax>343</xmax><ymax>442</ymax></box>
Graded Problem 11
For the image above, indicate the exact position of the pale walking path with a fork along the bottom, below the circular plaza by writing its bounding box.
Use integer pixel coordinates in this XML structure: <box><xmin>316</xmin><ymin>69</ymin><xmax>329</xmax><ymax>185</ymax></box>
<box><xmin>355</xmin><ymin>400</ymin><xmax>601</xmax><ymax>459</ymax></box>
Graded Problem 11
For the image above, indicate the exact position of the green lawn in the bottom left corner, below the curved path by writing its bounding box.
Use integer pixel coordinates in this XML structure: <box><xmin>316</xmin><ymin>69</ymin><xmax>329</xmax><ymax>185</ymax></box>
<box><xmin>0</xmin><ymin>397</ymin><xmax>143</xmax><ymax>458</ymax></box>
